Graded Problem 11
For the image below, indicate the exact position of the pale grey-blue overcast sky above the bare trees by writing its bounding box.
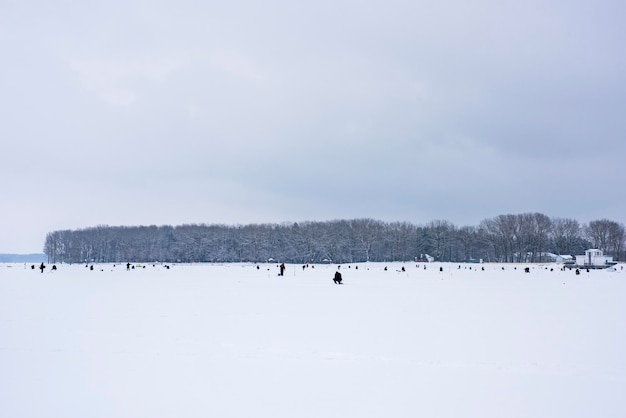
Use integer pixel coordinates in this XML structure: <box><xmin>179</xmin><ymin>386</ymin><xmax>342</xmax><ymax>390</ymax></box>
<box><xmin>0</xmin><ymin>0</ymin><xmax>626</xmax><ymax>253</ymax></box>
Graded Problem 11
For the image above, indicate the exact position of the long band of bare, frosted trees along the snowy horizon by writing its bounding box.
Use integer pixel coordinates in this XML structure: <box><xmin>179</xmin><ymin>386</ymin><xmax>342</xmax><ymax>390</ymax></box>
<box><xmin>44</xmin><ymin>213</ymin><xmax>626</xmax><ymax>263</ymax></box>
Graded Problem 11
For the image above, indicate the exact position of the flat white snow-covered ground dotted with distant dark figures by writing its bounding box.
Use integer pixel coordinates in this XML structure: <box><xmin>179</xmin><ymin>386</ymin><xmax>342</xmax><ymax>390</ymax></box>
<box><xmin>0</xmin><ymin>263</ymin><xmax>626</xmax><ymax>418</ymax></box>
